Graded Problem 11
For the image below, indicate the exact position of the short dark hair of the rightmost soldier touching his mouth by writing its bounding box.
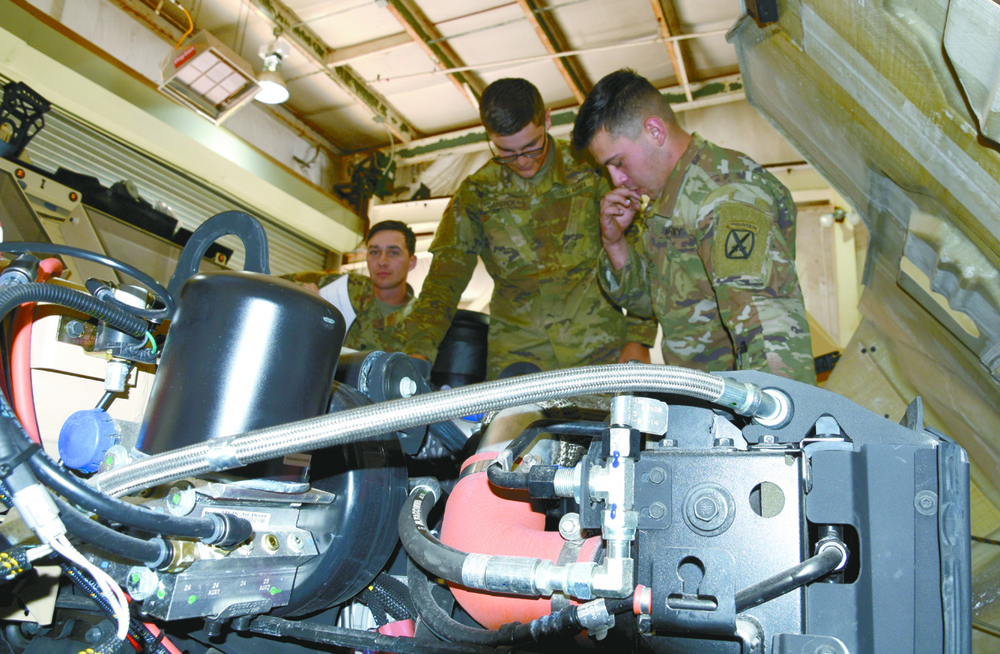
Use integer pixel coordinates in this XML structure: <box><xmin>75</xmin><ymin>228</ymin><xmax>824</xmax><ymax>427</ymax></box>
<box><xmin>573</xmin><ymin>68</ymin><xmax>677</xmax><ymax>150</ymax></box>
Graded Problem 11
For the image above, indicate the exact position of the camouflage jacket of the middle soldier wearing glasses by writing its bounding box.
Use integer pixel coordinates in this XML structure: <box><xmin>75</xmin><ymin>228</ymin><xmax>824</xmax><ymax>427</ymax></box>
<box><xmin>406</xmin><ymin>137</ymin><xmax>656</xmax><ymax>379</ymax></box>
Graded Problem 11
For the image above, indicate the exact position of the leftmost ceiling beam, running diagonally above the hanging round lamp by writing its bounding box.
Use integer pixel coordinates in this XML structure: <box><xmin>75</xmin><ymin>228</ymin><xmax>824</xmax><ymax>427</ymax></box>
<box><xmin>249</xmin><ymin>0</ymin><xmax>418</xmax><ymax>142</ymax></box>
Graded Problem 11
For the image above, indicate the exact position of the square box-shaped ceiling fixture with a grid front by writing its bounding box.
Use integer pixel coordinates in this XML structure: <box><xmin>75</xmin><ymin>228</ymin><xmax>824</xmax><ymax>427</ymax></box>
<box><xmin>159</xmin><ymin>30</ymin><xmax>260</xmax><ymax>125</ymax></box>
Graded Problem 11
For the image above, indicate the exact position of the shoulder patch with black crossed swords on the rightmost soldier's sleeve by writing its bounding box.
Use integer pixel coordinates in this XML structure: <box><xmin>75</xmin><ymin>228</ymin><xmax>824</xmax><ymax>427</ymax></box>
<box><xmin>712</xmin><ymin>201</ymin><xmax>771</xmax><ymax>278</ymax></box>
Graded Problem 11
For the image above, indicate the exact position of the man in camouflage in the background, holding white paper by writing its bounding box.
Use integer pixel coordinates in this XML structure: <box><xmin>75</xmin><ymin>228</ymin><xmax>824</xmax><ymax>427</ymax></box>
<box><xmin>285</xmin><ymin>220</ymin><xmax>417</xmax><ymax>352</ymax></box>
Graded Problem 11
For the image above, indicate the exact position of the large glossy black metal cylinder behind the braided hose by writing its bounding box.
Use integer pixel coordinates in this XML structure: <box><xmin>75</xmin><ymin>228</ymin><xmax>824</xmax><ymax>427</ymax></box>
<box><xmin>138</xmin><ymin>272</ymin><xmax>344</xmax><ymax>468</ymax></box>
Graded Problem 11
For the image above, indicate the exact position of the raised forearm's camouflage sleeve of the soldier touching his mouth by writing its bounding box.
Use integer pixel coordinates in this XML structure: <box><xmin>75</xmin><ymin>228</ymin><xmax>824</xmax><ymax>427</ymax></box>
<box><xmin>597</xmin><ymin>230</ymin><xmax>656</xmax><ymax>320</ymax></box>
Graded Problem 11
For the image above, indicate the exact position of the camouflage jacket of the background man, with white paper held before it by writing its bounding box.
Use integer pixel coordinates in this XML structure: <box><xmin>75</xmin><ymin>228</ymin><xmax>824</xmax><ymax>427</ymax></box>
<box><xmin>285</xmin><ymin>272</ymin><xmax>413</xmax><ymax>352</ymax></box>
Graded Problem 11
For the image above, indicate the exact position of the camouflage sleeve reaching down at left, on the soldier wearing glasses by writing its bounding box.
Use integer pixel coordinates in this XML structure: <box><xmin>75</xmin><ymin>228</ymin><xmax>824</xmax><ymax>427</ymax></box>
<box><xmin>405</xmin><ymin>184</ymin><xmax>486</xmax><ymax>361</ymax></box>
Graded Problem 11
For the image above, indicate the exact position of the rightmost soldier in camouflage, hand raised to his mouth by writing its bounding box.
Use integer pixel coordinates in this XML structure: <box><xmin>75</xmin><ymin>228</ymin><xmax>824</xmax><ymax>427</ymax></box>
<box><xmin>573</xmin><ymin>70</ymin><xmax>816</xmax><ymax>383</ymax></box>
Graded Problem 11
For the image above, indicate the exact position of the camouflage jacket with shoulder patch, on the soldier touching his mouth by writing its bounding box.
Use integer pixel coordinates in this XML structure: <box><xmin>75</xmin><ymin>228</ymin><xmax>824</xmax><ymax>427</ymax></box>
<box><xmin>600</xmin><ymin>134</ymin><xmax>816</xmax><ymax>383</ymax></box>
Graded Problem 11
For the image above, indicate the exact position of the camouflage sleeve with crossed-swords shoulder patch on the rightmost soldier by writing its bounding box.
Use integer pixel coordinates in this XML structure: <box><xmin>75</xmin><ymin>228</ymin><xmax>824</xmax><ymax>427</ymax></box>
<box><xmin>697</xmin><ymin>185</ymin><xmax>816</xmax><ymax>383</ymax></box>
